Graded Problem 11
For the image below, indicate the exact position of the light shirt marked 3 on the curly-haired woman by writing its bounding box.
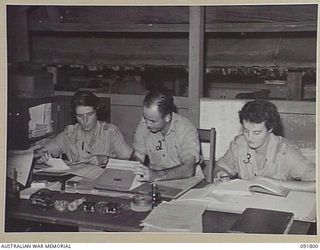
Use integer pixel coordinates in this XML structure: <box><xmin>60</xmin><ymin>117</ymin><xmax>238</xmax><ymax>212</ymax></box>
<box><xmin>216</xmin><ymin>134</ymin><xmax>316</xmax><ymax>181</ymax></box>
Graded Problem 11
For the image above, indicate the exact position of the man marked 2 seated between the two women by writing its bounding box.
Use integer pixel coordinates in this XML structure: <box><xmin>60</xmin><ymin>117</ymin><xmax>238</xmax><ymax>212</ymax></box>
<box><xmin>133</xmin><ymin>90</ymin><xmax>202</xmax><ymax>182</ymax></box>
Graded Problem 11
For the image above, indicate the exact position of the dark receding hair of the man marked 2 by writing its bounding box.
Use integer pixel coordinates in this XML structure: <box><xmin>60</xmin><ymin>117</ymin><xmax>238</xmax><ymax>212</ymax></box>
<box><xmin>143</xmin><ymin>89</ymin><xmax>177</xmax><ymax>118</ymax></box>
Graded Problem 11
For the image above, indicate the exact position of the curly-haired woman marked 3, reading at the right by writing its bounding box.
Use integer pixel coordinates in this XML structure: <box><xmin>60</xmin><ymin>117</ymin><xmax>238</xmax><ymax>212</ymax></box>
<box><xmin>214</xmin><ymin>100</ymin><xmax>316</xmax><ymax>191</ymax></box>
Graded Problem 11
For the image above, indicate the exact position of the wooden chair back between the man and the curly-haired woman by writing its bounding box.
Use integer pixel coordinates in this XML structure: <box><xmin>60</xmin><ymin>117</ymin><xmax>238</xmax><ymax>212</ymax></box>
<box><xmin>198</xmin><ymin>128</ymin><xmax>216</xmax><ymax>182</ymax></box>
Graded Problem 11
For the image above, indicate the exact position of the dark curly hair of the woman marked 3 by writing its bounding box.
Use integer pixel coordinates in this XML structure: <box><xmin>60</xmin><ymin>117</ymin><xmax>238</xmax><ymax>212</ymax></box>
<box><xmin>239</xmin><ymin>100</ymin><xmax>282</xmax><ymax>135</ymax></box>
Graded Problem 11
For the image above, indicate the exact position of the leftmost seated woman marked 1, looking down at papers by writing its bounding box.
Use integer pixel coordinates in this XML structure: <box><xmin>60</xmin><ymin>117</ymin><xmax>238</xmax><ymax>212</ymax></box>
<box><xmin>37</xmin><ymin>91</ymin><xmax>133</xmax><ymax>165</ymax></box>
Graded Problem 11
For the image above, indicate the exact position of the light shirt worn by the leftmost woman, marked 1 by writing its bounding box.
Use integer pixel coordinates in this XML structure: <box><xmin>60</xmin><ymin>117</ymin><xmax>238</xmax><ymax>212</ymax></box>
<box><xmin>44</xmin><ymin>121</ymin><xmax>133</xmax><ymax>161</ymax></box>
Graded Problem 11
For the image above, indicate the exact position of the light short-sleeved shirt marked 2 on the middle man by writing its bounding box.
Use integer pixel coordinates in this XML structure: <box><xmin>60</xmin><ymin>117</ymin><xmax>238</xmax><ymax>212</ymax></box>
<box><xmin>133</xmin><ymin>113</ymin><xmax>200</xmax><ymax>170</ymax></box>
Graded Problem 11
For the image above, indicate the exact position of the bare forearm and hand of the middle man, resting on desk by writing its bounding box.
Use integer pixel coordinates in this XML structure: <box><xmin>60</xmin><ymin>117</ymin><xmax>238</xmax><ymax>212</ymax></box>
<box><xmin>135</xmin><ymin>154</ymin><xmax>197</xmax><ymax>182</ymax></box>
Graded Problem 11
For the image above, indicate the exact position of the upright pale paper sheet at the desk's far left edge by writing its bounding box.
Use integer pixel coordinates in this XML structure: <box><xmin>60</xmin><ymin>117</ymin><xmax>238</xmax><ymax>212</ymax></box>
<box><xmin>7</xmin><ymin>148</ymin><xmax>33</xmax><ymax>186</ymax></box>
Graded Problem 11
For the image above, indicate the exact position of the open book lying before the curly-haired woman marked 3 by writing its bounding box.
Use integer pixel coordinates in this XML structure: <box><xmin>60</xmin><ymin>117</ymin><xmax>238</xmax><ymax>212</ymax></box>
<box><xmin>212</xmin><ymin>178</ymin><xmax>289</xmax><ymax>197</ymax></box>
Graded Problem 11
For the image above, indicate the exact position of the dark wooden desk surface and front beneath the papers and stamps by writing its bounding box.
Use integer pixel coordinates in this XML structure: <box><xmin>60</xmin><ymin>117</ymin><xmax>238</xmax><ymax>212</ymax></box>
<box><xmin>7</xmin><ymin>192</ymin><xmax>316</xmax><ymax>235</ymax></box>
